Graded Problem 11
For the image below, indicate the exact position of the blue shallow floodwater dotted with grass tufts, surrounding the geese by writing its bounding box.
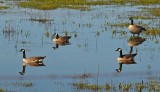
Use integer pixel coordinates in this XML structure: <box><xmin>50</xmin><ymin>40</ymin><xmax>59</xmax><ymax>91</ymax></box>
<box><xmin>0</xmin><ymin>1</ymin><xmax>160</xmax><ymax>92</ymax></box>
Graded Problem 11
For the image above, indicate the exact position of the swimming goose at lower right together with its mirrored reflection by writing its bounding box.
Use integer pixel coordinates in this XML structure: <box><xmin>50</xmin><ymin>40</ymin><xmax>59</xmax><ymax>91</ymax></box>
<box><xmin>116</xmin><ymin>48</ymin><xmax>137</xmax><ymax>72</ymax></box>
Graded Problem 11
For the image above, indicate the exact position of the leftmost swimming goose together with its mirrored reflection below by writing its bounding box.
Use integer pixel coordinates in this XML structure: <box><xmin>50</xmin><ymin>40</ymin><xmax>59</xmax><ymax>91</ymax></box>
<box><xmin>19</xmin><ymin>49</ymin><xmax>46</xmax><ymax>75</ymax></box>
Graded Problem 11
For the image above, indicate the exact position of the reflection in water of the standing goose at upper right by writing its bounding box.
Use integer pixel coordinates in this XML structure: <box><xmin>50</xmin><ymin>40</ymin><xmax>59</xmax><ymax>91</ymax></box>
<box><xmin>128</xmin><ymin>36</ymin><xmax>146</xmax><ymax>53</ymax></box>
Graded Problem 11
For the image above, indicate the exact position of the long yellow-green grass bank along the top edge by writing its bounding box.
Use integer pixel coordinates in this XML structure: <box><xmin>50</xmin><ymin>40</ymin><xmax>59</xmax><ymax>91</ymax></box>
<box><xmin>18</xmin><ymin>0</ymin><xmax>160</xmax><ymax>10</ymax></box>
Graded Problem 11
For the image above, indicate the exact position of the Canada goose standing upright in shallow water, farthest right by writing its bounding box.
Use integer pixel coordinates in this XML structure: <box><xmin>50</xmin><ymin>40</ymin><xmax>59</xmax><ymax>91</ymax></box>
<box><xmin>128</xmin><ymin>17</ymin><xmax>146</xmax><ymax>36</ymax></box>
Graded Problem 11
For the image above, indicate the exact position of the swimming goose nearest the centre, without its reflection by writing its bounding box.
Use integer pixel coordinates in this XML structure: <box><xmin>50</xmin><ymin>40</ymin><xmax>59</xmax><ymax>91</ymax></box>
<box><xmin>53</xmin><ymin>33</ymin><xmax>71</xmax><ymax>42</ymax></box>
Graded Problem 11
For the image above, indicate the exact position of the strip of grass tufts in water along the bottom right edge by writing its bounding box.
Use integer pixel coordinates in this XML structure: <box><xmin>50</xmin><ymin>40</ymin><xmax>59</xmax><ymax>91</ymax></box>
<box><xmin>72</xmin><ymin>80</ymin><xmax>160</xmax><ymax>92</ymax></box>
